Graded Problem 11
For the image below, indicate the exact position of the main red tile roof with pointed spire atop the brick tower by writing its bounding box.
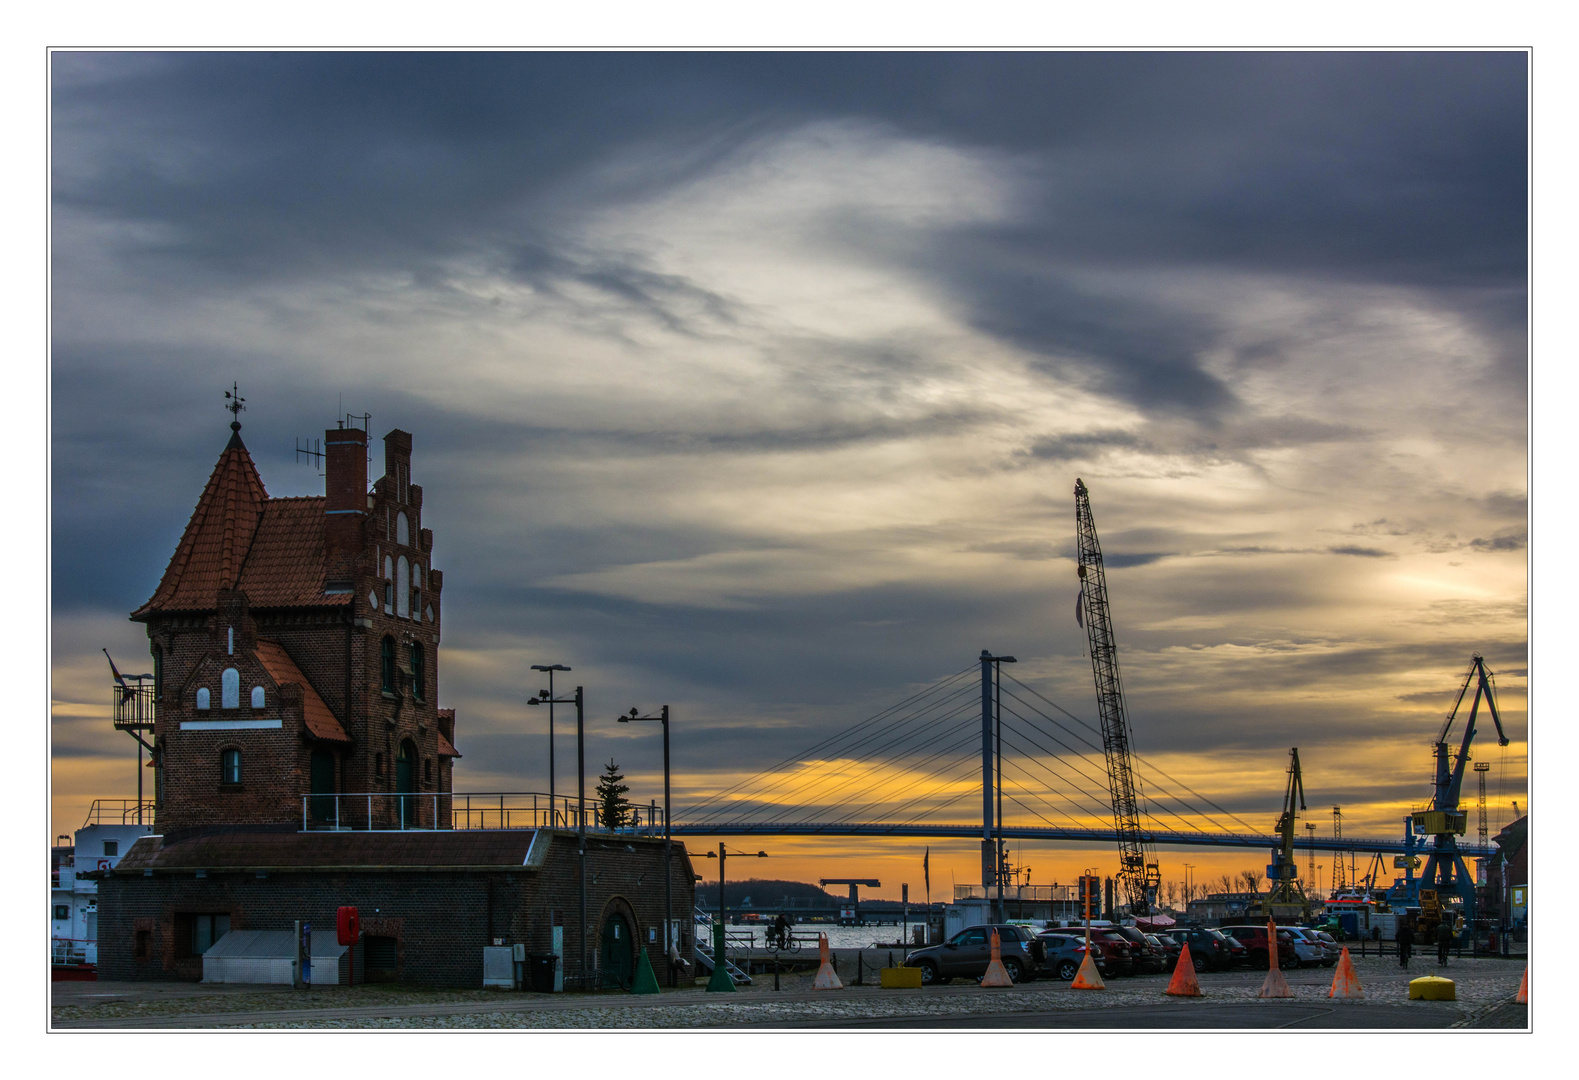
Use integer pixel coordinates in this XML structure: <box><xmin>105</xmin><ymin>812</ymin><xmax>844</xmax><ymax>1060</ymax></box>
<box><xmin>131</xmin><ymin>433</ymin><xmax>351</xmax><ymax>619</ymax></box>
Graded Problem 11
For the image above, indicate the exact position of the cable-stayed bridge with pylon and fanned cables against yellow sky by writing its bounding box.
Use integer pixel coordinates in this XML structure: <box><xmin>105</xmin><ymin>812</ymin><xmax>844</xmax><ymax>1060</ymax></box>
<box><xmin>673</xmin><ymin>652</ymin><xmax>1418</xmax><ymax>872</ymax></box>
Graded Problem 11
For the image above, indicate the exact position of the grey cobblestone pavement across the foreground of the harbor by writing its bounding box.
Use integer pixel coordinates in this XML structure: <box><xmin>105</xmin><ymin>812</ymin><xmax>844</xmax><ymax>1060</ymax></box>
<box><xmin>54</xmin><ymin>957</ymin><xmax>1525</xmax><ymax>1029</ymax></box>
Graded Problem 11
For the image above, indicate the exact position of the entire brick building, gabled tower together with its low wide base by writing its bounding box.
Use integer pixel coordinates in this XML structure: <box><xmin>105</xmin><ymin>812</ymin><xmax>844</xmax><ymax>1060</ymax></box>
<box><xmin>99</xmin><ymin>423</ymin><xmax>695</xmax><ymax>987</ymax></box>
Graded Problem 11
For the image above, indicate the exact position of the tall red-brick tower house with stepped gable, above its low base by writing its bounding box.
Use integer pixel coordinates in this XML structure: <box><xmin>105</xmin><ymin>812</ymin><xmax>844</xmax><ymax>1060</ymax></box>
<box><xmin>131</xmin><ymin>423</ymin><xmax>459</xmax><ymax>843</ymax></box>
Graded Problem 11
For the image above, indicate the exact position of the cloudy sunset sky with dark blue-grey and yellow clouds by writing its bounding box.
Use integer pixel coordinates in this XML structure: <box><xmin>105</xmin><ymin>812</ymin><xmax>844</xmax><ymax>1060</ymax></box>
<box><xmin>51</xmin><ymin>52</ymin><xmax>1528</xmax><ymax>897</ymax></box>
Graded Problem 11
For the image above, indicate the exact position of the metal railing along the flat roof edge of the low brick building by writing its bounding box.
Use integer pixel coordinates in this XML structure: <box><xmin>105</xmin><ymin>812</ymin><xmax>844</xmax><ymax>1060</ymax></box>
<box><xmin>302</xmin><ymin>791</ymin><xmax>663</xmax><ymax>837</ymax></box>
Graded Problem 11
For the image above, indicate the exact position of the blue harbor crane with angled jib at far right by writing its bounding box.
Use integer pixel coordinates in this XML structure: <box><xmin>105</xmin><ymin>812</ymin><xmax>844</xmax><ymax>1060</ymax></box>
<box><xmin>1388</xmin><ymin>652</ymin><xmax>1508</xmax><ymax>930</ymax></box>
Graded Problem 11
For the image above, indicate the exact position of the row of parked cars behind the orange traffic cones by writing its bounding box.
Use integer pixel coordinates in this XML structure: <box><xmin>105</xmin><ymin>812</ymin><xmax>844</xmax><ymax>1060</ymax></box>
<box><xmin>905</xmin><ymin>924</ymin><xmax>1342</xmax><ymax>985</ymax></box>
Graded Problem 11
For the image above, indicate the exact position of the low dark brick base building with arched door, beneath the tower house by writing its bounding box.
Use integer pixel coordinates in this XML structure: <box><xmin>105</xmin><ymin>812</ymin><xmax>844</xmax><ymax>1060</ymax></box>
<box><xmin>99</xmin><ymin>829</ymin><xmax>695</xmax><ymax>987</ymax></box>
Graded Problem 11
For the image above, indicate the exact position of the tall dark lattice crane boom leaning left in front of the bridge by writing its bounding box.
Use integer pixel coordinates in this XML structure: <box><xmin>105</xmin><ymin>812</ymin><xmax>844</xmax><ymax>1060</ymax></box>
<box><xmin>1075</xmin><ymin>480</ymin><xmax>1162</xmax><ymax>914</ymax></box>
